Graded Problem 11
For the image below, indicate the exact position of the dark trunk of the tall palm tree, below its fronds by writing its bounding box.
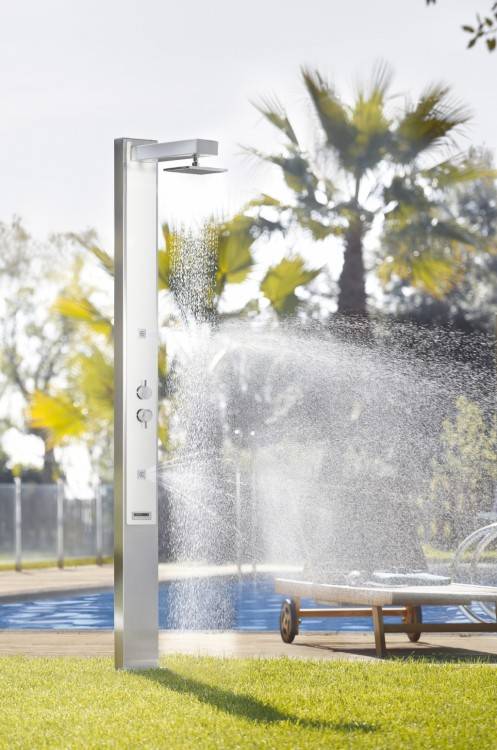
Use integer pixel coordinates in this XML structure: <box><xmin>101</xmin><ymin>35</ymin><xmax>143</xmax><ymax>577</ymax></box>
<box><xmin>337</xmin><ymin>220</ymin><xmax>368</xmax><ymax>318</ymax></box>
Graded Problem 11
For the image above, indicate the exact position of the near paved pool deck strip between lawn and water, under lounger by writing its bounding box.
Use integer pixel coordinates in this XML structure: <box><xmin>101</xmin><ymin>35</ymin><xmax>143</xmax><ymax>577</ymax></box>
<box><xmin>0</xmin><ymin>630</ymin><xmax>497</xmax><ymax>665</ymax></box>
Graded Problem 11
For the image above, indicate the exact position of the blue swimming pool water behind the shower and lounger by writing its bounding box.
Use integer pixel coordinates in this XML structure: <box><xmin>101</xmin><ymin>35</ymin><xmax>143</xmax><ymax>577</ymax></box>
<box><xmin>0</xmin><ymin>578</ymin><xmax>474</xmax><ymax>631</ymax></box>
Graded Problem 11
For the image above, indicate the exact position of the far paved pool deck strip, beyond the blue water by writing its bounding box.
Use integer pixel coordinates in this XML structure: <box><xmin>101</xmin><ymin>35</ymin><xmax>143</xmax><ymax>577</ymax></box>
<box><xmin>0</xmin><ymin>563</ymin><xmax>300</xmax><ymax>603</ymax></box>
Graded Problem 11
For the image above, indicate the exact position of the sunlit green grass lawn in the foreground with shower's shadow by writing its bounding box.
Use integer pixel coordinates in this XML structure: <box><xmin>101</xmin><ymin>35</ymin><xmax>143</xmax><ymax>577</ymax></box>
<box><xmin>0</xmin><ymin>656</ymin><xmax>497</xmax><ymax>750</ymax></box>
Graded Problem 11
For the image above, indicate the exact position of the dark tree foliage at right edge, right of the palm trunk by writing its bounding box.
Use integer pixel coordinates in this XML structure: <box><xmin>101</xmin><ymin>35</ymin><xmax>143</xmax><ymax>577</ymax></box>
<box><xmin>378</xmin><ymin>149</ymin><xmax>497</xmax><ymax>333</ymax></box>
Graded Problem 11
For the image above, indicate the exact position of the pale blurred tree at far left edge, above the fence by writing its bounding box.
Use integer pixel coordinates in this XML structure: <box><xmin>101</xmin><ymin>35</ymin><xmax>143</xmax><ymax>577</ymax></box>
<box><xmin>0</xmin><ymin>219</ymin><xmax>76</xmax><ymax>482</ymax></box>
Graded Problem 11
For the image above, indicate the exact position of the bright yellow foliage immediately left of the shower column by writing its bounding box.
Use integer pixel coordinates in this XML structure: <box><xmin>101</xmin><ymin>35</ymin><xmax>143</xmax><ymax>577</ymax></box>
<box><xmin>28</xmin><ymin>242</ymin><xmax>114</xmax><ymax>480</ymax></box>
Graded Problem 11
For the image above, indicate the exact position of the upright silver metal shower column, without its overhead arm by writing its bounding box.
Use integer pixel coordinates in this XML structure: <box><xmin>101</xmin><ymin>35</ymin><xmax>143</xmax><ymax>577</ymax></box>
<box><xmin>114</xmin><ymin>138</ymin><xmax>159</xmax><ymax>669</ymax></box>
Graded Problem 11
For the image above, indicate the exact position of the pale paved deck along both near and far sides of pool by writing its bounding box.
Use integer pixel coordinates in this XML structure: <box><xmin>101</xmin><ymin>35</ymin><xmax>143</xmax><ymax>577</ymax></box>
<box><xmin>0</xmin><ymin>564</ymin><xmax>497</xmax><ymax>664</ymax></box>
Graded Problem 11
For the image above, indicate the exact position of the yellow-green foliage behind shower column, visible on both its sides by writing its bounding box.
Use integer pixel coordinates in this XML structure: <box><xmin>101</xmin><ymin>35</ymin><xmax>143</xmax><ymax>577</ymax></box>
<box><xmin>27</xmin><ymin>214</ymin><xmax>318</xmax><ymax>468</ymax></box>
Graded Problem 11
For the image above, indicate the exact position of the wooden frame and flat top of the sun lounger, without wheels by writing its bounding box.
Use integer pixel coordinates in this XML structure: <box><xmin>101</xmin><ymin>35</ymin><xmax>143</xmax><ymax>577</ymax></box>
<box><xmin>275</xmin><ymin>578</ymin><xmax>497</xmax><ymax>657</ymax></box>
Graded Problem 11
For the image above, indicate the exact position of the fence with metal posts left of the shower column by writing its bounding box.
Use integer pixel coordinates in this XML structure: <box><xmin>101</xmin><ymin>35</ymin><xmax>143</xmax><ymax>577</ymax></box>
<box><xmin>0</xmin><ymin>479</ymin><xmax>113</xmax><ymax>570</ymax></box>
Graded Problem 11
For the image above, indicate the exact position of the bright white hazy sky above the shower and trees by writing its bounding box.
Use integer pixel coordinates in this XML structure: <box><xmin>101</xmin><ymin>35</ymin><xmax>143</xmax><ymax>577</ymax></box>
<box><xmin>0</xmin><ymin>0</ymin><xmax>497</xmax><ymax>253</ymax></box>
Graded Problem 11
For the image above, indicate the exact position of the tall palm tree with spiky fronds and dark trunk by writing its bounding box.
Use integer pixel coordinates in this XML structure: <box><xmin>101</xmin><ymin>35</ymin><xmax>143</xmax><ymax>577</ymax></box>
<box><xmin>249</xmin><ymin>66</ymin><xmax>488</xmax><ymax>317</ymax></box>
